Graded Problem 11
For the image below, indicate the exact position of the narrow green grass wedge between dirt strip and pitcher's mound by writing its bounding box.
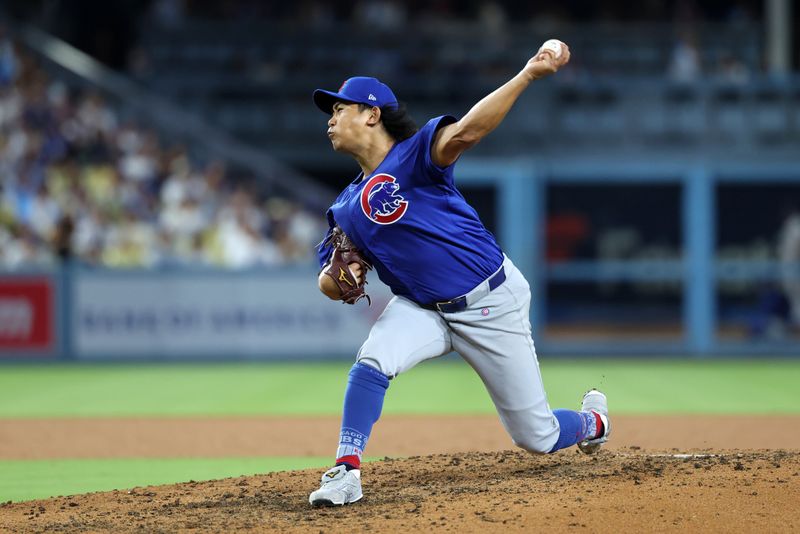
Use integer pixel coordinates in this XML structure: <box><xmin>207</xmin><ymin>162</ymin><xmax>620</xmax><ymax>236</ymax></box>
<box><xmin>0</xmin><ymin>457</ymin><xmax>330</xmax><ymax>502</ymax></box>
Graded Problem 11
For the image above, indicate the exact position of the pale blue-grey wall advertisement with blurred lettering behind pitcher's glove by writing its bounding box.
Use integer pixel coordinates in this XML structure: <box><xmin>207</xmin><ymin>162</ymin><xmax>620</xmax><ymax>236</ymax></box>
<box><xmin>76</xmin><ymin>272</ymin><xmax>391</xmax><ymax>359</ymax></box>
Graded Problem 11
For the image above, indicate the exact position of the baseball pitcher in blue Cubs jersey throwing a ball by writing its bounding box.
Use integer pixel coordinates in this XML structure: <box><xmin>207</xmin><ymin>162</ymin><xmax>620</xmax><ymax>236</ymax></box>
<box><xmin>309</xmin><ymin>40</ymin><xmax>611</xmax><ymax>506</ymax></box>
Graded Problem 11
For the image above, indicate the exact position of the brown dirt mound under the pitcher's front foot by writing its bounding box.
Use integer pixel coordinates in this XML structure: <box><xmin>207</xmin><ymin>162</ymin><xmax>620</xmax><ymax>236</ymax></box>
<box><xmin>0</xmin><ymin>447</ymin><xmax>800</xmax><ymax>532</ymax></box>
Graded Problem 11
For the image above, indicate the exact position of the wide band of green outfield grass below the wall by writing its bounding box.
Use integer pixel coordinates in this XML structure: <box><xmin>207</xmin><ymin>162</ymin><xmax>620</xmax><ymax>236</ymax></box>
<box><xmin>0</xmin><ymin>360</ymin><xmax>800</xmax><ymax>418</ymax></box>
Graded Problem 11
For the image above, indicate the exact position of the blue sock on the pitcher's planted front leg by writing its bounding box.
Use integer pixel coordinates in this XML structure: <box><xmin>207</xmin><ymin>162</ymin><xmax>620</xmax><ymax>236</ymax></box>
<box><xmin>336</xmin><ymin>363</ymin><xmax>389</xmax><ymax>469</ymax></box>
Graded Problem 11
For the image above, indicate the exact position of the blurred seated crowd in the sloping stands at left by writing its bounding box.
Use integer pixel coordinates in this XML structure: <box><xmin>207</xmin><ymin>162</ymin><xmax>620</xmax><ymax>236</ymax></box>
<box><xmin>0</xmin><ymin>35</ymin><xmax>323</xmax><ymax>269</ymax></box>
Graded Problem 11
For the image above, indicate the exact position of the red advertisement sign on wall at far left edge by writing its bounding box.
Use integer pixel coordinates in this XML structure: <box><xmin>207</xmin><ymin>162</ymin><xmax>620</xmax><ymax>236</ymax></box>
<box><xmin>0</xmin><ymin>276</ymin><xmax>55</xmax><ymax>356</ymax></box>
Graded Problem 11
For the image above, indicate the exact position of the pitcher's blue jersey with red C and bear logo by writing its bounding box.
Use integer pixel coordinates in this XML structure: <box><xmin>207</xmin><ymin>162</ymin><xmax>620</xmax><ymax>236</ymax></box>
<box><xmin>318</xmin><ymin>116</ymin><xmax>503</xmax><ymax>304</ymax></box>
